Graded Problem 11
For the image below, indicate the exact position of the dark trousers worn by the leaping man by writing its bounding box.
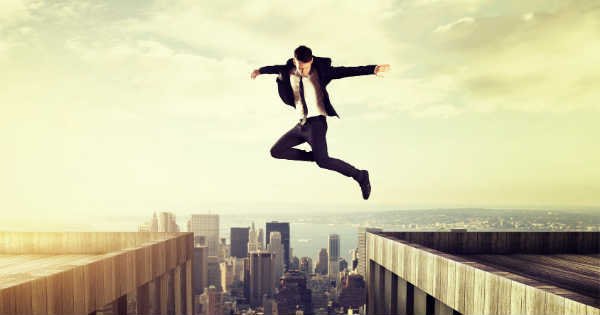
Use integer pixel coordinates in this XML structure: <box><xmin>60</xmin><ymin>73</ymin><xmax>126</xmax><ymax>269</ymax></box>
<box><xmin>271</xmin><ymin>116</ymin><xmax>360</xmax><ymax>180</ymax></box>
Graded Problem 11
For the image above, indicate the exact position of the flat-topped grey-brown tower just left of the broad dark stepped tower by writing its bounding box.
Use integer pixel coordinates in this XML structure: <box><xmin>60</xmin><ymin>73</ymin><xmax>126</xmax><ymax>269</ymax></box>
<box><xmin>248</xmin><ymin>251</ymin><xmax>275</xmax><ymax>307</ymax></box>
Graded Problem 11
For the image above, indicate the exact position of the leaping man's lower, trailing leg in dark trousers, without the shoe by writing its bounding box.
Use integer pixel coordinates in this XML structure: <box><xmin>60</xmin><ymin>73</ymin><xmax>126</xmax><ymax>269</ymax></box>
<box><xmin>308</xmin><ymin>119</ymin><xmax>364</xmax><ymax>182</ymax></box>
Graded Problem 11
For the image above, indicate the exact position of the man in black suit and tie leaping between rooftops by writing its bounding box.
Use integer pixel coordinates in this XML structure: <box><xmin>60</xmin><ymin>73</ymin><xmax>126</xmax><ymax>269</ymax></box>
<box><xmin>250</xmin><ymin>46</ymin><xmax>390</xmax><ymax>200</ymax></box>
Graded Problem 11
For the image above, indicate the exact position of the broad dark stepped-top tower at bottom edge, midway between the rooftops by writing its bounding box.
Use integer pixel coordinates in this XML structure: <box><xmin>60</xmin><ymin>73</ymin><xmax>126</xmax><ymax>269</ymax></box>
<box><xmin>275</xmin><ymin>271</ymin><xmax>312</xmax><ymax>314</ymax></box>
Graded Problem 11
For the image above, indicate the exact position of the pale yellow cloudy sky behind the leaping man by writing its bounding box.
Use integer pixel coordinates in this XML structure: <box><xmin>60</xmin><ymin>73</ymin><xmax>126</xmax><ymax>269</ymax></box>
<box><xmin>0</xmin><ymin>0</ymin><xmax>600</xmax><ymax>220</ymax></box>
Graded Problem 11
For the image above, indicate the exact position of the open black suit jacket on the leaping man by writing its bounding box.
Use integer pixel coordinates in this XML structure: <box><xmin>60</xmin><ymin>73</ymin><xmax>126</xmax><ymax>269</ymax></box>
<box><xmin>258</xmin><ymin>56</ymin><xmax>376</xmax><ymax>118</ymax></box>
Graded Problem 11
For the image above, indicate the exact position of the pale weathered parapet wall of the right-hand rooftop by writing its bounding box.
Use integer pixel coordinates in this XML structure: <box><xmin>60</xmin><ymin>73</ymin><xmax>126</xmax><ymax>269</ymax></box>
<box><xmin>366</xmin><ymin>233</ymin><xmax>600</xmax><ymax>314</ymax></box>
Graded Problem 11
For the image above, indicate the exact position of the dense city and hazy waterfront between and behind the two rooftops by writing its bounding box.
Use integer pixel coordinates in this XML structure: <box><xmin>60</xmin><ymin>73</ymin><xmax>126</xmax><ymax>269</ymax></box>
<box><xmin>138</xmin><ymin>209</ymin><xmax>600</xmax><ymax>315</ymax></box>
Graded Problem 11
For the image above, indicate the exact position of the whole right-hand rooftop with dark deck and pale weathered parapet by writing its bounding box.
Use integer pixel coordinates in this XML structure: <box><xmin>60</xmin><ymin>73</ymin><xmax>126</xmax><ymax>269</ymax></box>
<box><xmin>366</xmin><ymin>232</ymin><xmax>600</xmax><ymax>314</ymax></box>
